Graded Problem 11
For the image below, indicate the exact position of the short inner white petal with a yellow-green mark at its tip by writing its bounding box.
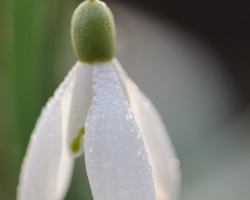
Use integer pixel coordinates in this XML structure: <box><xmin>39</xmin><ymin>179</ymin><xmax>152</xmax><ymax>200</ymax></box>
<box><xmin>67</xmin><ymin>62</ymin><xmax>93</xmax><ymax>157</ymax></box>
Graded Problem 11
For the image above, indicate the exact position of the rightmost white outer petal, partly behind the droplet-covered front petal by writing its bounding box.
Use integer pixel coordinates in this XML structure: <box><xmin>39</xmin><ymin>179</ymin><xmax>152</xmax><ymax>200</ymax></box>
<box><xmin>112</xmin><ymin>59</ymin><xmax>181</xmax><ymax>200</ymax></box>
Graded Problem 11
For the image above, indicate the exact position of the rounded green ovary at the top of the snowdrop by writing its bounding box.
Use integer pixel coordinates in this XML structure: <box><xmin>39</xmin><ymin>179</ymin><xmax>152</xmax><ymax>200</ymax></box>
<box><xmin>71</xmin><ymin>0</ymin><xmax>116</xmax><ymax>64</ymax></box>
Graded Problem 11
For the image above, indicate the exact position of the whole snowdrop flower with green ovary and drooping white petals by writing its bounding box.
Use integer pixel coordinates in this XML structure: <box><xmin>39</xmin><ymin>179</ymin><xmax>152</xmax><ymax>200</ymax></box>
<box><xmin>17</xmin><ymin>0</ymin><xmax>182</xmax><ymax>200</ymax></box>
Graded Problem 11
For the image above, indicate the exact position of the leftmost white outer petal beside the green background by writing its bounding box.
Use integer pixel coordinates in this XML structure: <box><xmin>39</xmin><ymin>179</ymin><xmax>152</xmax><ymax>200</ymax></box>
<box><xmin>17</xmin><ymin>65</ymin><xmax>78</xmax><ymax>200</ymax></box>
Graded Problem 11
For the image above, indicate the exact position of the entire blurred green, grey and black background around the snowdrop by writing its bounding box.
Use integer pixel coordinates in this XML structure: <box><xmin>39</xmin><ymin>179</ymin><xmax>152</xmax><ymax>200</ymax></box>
<box><xmin>0</xmin><ymin>0</ymin><xmax>250</xmax><ymax>200</ymax></box>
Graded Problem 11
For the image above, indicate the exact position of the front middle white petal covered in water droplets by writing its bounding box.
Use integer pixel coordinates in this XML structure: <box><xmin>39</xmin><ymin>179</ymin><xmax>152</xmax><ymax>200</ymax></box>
<box><xmin>84</xmin><ymin>63</ymin><xmax>155</xmax><ymax>200</ymax></box>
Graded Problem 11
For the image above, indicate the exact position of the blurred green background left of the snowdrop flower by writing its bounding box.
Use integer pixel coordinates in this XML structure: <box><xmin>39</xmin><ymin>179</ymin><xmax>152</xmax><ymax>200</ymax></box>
<box><xmin>0</xmin><ymin>0</ymin><xmax>93</xmax><ymax>200</ymax></box>
